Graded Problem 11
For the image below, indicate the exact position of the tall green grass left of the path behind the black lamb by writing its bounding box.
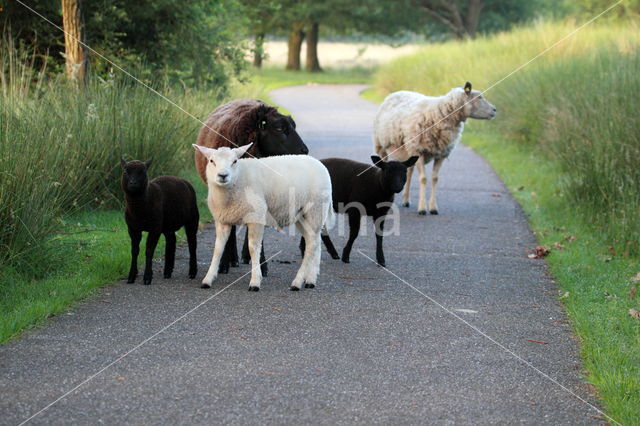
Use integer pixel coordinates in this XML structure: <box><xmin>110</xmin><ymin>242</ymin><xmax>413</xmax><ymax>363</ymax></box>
<box><xmin>0</xmin><ymin>39</ymin><xmax>199</xmax><ymax>266</ymax></box>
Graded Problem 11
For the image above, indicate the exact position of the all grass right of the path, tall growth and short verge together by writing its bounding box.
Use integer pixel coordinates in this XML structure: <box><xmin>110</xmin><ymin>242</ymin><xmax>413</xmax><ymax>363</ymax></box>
<box><xmin>365</xmin><ymin>22</ymin><xmax>640</xmax><ymax>424</ymax></box>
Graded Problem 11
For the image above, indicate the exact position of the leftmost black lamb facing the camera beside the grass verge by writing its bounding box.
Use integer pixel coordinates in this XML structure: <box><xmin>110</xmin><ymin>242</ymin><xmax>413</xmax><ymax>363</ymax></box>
<box><xmin>120</xmin><ymin>158</ymin><xmax>200</xmax><ymax>284</ymax></box>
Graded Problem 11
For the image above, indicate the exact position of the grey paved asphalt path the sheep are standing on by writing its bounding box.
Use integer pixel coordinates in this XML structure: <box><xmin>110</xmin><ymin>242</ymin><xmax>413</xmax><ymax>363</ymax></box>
<box><xmin>0</xmin><ymin>86</ymin><xmax>601</xmax><ymax>424</ymax></box>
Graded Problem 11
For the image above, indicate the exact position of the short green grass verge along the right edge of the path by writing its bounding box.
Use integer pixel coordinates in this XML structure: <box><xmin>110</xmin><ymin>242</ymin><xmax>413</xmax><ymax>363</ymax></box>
<box><xmin>464</xmin><ymin>126</ymin><xmax>640</xmax><ymax>425</ymax></box>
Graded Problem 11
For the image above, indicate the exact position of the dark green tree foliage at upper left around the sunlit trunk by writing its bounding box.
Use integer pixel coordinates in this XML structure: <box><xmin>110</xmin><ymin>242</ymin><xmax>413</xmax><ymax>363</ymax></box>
<box><xmin>0</xmin><ymin>0</ymin><xmax>248</xmax><ymax>92</ymax></box>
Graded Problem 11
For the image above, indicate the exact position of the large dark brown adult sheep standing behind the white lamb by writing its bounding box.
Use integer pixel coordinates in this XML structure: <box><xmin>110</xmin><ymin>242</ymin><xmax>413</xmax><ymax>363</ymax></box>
<box><xmin>195</xmin><ymin>99</ymin><xmax>309</xmax><ymax>276</ymax></box>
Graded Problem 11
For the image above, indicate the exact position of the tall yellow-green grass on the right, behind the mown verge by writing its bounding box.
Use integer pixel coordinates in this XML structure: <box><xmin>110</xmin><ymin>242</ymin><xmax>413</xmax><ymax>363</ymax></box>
<box><xmin>376</xmin><ymin>22</ymin><xmax>640</xmax><ymax>256</ymax></box>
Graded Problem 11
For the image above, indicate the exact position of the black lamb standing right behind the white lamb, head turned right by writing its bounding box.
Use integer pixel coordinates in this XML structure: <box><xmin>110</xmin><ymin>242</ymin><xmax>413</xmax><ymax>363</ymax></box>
<box><xmin>300</xmin><ymin>155</ymin><xmax>418</xmax><ymax>266</ymax></box>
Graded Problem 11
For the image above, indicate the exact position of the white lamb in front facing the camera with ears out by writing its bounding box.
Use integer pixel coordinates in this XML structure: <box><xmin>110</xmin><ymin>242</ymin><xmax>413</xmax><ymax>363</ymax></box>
<box><xmin>193</xmin><ymin>144</ymin><xmax>334</xmax><ymax>291</ymax></box>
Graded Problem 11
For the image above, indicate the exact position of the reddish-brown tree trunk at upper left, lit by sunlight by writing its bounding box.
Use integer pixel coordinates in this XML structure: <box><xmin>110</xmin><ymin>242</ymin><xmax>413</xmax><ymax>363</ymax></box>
<box><xmin>62</xmin><ymin>0</ymin><xmax>88</xmax><ymax>82</ymax></box>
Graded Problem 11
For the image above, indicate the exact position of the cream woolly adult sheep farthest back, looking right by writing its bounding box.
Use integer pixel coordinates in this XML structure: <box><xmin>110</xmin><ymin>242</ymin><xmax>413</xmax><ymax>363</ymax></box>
<box><xmin>373</xmin><ymin>82</ymin><xmax>496</xmax><ymax>215</ymax></box>
